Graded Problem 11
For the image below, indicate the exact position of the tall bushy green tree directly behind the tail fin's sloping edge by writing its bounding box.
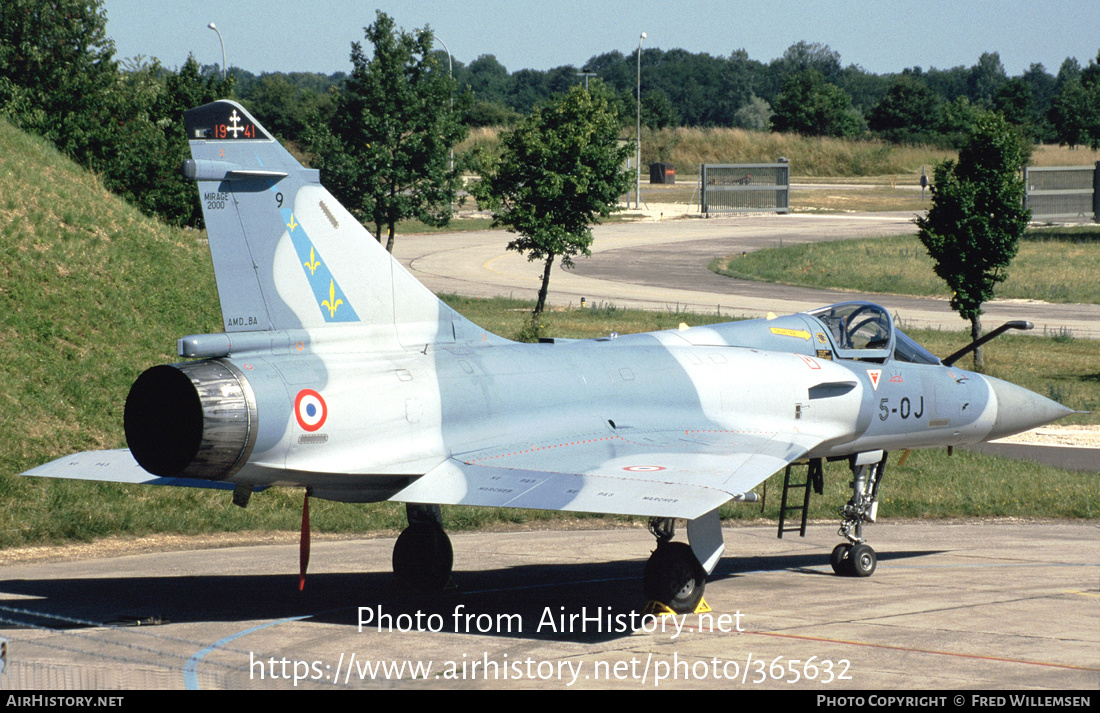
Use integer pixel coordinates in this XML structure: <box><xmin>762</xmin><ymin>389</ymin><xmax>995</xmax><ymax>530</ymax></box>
<box><xmin>307</xmin><ymin>11</ymin><xmax>466</xmax><ymax>252</ymax></box>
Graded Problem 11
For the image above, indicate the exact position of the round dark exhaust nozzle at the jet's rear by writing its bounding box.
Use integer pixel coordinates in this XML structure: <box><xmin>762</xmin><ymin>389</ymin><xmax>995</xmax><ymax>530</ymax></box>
<box><xmin>123</xmin><ymin>360</ymin><xmax>256</xmax><ymax>480</ymax></box>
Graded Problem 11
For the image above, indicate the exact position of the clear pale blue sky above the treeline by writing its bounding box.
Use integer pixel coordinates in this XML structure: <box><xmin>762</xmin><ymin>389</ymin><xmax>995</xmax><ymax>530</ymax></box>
<box><xmin>103</xmin><ymin>0</ymin><xmax>1100</xmax><ymax>76</ymax></box>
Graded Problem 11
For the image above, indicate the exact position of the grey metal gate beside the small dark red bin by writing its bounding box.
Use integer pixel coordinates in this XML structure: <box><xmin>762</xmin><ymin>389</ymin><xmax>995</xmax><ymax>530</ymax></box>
<box><xmin>699</xmin><ymin>162</ymin><xmax>791</xmax><ymax>215</ymax></box>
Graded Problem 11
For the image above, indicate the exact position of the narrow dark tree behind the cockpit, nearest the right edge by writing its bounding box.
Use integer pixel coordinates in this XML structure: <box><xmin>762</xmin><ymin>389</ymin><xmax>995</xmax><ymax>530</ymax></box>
<box><xmin>915</xmin><ymin>113</ymin><xmax>1031</xmax><ymax>371</ymax></box>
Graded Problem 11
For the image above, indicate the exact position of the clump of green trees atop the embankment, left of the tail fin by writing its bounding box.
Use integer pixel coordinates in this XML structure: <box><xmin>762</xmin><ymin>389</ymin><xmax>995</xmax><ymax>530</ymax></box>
<box><xmin>0</xmin><ymin>0</ymin><xmax>232</xmax><ymax>224</ymax></box>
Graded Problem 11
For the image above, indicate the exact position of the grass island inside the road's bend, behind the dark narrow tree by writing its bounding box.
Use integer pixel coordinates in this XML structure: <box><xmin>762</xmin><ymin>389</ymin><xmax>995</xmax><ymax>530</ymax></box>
<box><xmin>711</xmin><ymin>226</ymin><xmax>1100</xmax><ymax>305</ymax></box>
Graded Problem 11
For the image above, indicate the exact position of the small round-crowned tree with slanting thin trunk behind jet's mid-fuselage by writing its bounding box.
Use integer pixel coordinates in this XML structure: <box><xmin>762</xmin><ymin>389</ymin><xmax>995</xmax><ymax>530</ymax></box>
<box><xmin>471</xmin><ymin>81</ymin><xmax>634</xmax><ymax>329</ymax></box>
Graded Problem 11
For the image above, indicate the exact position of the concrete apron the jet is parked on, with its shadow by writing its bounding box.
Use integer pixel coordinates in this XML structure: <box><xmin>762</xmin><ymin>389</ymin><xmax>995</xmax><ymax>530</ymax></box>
<box><xmin>0</xmin><ymin>520</ymin><xmax>1100</xmax><ymax>694</ymax></box>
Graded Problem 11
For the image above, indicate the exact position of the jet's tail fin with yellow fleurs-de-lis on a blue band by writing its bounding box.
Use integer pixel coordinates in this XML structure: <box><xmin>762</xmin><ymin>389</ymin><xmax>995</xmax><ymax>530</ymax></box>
<box><xmin>184</xmin><ymin>100</ymin><xmax>464</xmax><ymax>343</ymax></box>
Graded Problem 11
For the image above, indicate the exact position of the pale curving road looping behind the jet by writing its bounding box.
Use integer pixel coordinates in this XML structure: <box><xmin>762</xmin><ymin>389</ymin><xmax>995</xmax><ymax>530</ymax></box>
<box><xmin>395</xmin><ymin>211</ymin><xmax>1100</xmax><ymax>338</ymax></box>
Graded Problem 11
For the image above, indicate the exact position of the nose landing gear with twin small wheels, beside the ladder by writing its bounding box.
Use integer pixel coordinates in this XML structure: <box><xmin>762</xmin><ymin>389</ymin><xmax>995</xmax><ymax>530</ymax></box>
<box><xmin>829</xmin><ymin>451</ymin><xmax>887</xmax><ymax>577</ymax></box>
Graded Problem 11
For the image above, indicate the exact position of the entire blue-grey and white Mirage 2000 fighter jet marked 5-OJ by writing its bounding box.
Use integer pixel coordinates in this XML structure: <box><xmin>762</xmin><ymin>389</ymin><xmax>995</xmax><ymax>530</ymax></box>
<box><xmin>25</xmin><ymin>101</ymin><xmax>1071</xmax><ymax>612</ymax></box>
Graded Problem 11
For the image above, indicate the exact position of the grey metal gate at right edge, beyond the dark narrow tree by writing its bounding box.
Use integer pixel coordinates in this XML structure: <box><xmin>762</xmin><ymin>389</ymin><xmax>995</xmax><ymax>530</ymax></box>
<box><xmin>1024</xmin><ymin>162</ymin><xmax>1100</xmax><ymax>220</ymax></box>
